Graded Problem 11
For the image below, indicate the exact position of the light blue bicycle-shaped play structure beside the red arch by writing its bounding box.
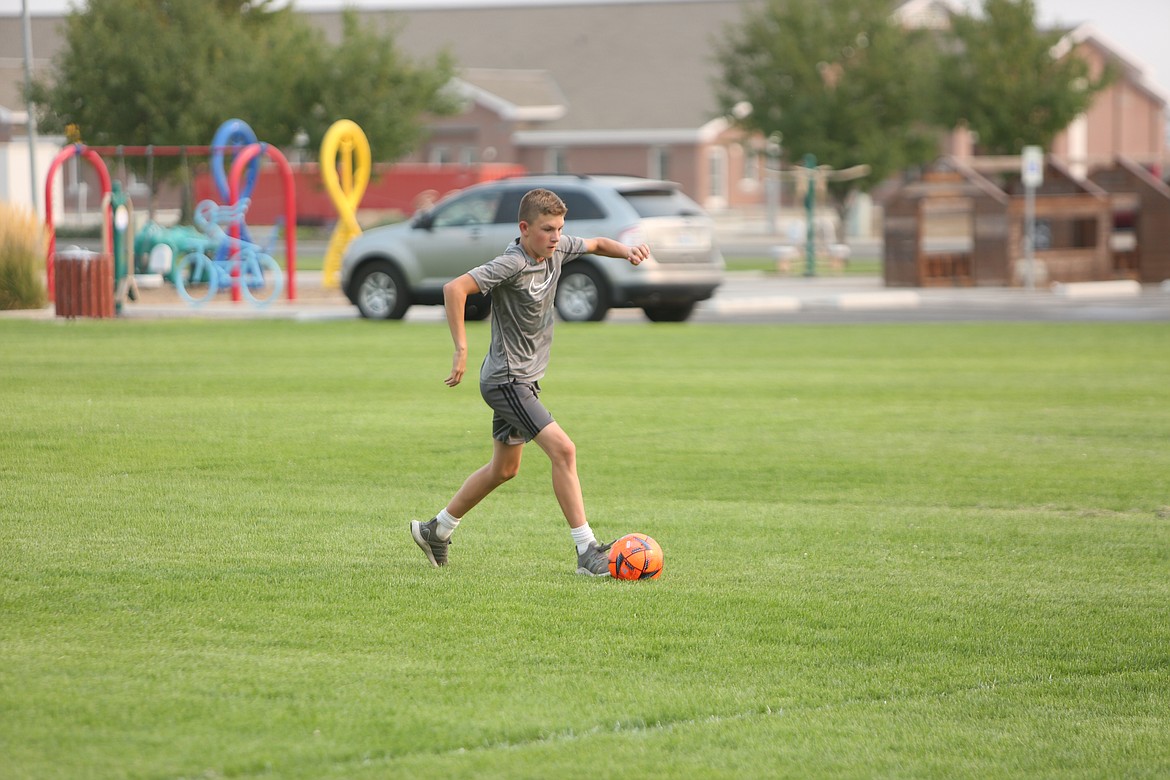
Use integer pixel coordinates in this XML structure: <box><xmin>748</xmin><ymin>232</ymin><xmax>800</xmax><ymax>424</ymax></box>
<box><xmin>173</xmin><ymin>198</ymin><xmax>284</xmax><ymax>305</ymax></box>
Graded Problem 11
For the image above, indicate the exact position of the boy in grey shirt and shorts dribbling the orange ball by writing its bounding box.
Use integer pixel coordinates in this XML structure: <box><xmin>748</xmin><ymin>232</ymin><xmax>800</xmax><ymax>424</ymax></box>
<box><xmin>411</xmin><ymin>189</ymin><xmax>651</xmax><ymax>577</ymax></box>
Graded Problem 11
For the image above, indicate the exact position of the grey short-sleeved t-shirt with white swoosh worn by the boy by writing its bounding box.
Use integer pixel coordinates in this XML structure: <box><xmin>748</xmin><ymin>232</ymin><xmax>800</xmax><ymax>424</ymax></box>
<box><xmin>468</xmin><ymin>235</ymin><xmax>585</xmax><ymax>385</ymax></box>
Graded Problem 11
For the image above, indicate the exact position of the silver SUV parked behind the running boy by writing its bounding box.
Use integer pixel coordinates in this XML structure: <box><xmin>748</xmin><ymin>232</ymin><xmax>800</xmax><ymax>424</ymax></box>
<box><xmin>340</xmin><ymin>175</ymin><xmax>723</xmax><ymax>322</ymax></box>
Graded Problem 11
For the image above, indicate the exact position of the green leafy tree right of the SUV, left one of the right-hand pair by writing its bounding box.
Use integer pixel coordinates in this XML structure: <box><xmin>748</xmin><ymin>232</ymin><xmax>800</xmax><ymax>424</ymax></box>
<box><xmin>716</xmin><ymin>0</ymin><xmax>938</xmax><ymax>205</ymax></box>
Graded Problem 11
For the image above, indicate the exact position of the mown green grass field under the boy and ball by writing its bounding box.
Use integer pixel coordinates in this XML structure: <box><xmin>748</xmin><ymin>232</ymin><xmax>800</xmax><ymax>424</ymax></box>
<box><xmin>0</xmin><ymin>319</ymin><xmax>1170</xmax><ymax>779</ymax></box>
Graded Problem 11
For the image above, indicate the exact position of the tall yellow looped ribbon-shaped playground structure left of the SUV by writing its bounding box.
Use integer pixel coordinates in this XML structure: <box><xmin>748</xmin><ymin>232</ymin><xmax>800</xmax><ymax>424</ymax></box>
<box><xmin>321</xmin><ymin>119</ymin><xmax>371</xmax><ymax>288</ymax></box>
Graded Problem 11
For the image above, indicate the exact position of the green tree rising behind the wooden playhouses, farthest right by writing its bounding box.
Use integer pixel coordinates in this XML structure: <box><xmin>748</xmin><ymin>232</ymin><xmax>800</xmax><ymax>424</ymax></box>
<box><xmin>940</xmin><ymin>0</ymin><xmax>1114</xmax><ymax>154</ymax></box>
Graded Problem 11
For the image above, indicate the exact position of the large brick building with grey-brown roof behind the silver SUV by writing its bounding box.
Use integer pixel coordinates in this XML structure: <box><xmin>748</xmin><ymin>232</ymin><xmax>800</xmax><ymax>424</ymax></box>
<box><xmin>311</xmin><ymin>0</ymin><xmax>759</xmax><ymax>209</ymax></box>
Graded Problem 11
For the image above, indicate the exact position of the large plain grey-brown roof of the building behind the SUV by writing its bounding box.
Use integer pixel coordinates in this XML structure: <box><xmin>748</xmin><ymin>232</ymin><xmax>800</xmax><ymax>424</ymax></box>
<box><xmin>305</xmin><ymin>0</ymin><xmax>756</xmax><ymax>134</ymax></box>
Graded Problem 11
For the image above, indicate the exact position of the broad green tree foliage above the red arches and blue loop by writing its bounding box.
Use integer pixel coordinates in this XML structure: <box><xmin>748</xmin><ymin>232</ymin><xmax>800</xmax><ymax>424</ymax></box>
<box><xmin>29</xmin><ymin>0</ymin><xmax>454</xmax><ymax>161</ymax></box>
